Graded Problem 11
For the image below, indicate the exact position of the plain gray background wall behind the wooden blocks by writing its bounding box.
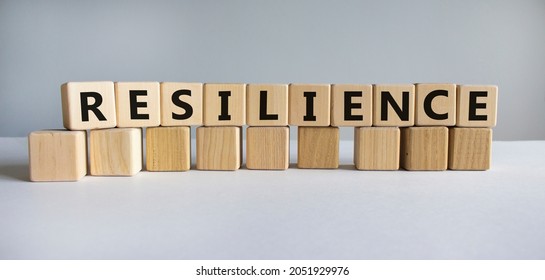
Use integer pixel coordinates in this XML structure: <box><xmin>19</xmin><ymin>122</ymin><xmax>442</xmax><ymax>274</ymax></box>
<box><xmin>0</xmin><ymin>0</ymin><xmax>545</xmax><ymax>140</ymax></box>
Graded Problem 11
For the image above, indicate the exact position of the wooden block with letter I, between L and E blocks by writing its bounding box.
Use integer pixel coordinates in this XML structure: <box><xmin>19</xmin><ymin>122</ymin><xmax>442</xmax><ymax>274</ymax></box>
<box><xmin>289</xmin><ymin>84</ymin><xmax>331</xmax><ymax>126</ymax></box>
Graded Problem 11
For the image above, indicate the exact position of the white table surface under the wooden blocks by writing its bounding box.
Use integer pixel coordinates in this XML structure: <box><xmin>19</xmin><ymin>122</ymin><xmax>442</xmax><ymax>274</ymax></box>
<box><xmin>0</xmin><ymin>138</ymin><xmax>545</xmax><ymax>259</ymax></box>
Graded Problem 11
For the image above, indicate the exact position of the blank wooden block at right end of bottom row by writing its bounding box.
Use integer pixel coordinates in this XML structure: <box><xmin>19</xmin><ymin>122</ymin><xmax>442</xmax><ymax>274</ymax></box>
<box><xmin>448</xmin><ymin>127</ymin><xmax>492</xmax><ymax>170</ymax></box>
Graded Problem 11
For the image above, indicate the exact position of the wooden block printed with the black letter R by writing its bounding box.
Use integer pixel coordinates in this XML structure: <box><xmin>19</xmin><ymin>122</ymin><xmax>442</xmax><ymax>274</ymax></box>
<box><xmin>61</xmin><ymin>82</ymin><xmax>117</xmax><ymax>130</ymax></box>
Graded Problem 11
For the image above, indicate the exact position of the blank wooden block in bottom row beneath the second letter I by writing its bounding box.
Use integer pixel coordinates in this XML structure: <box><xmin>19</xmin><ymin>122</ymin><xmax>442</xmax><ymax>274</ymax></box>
<box><xmin>297</xmin><ymin>126</ymin><xmax>339</xmax><ymax>168</ymax></box>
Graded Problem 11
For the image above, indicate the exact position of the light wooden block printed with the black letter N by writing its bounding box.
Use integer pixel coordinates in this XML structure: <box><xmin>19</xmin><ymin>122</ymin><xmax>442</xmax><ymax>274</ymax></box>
<box><xmin>373</xmin><ymin>84</ymin><xmax>415</xmax><ymax>127</ymax></box>
